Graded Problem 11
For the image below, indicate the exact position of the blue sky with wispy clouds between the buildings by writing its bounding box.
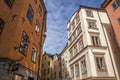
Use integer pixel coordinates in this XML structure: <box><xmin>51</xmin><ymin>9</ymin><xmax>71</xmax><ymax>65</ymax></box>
<box><xmin>43</xmin><ymin>0</ymin><xmax>104</xmax><ymax>54</ymax></box>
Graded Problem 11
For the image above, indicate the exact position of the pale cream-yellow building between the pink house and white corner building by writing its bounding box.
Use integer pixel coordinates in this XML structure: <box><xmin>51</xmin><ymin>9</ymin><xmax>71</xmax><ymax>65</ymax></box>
<box><xmin>60</xmin><ymin>44</ymin><xmax>70</xmax><ymax>80</ymax></box>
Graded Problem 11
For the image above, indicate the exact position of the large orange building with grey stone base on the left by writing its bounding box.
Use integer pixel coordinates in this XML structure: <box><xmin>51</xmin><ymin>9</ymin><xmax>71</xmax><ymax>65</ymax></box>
<box><xmin>0</xmin><ymin>0</ymin><xmax>46</xmax><ymax>80</ymax></box>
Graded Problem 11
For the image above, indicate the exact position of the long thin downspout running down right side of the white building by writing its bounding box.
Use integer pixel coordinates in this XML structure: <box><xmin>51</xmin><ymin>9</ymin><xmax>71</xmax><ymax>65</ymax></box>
<box><xmin>97</xmin><ymin>10</ymin><xmax>117</xmax><ymax>80</ymax></box>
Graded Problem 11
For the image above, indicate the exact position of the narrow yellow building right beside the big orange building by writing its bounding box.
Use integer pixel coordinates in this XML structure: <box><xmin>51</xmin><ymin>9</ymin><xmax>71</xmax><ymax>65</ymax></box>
<box><xmin>41</xmin><ymin>52</ymin><xmax>53</xmax><ymax>80</ymax></box>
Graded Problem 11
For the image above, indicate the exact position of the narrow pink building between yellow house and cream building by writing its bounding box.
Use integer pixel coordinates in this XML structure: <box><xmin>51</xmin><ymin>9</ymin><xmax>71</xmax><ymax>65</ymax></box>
<box><xmin>52</xmin><ymin>54</ymin><xmax>61</xmax><ymax>80</ymax></box>
